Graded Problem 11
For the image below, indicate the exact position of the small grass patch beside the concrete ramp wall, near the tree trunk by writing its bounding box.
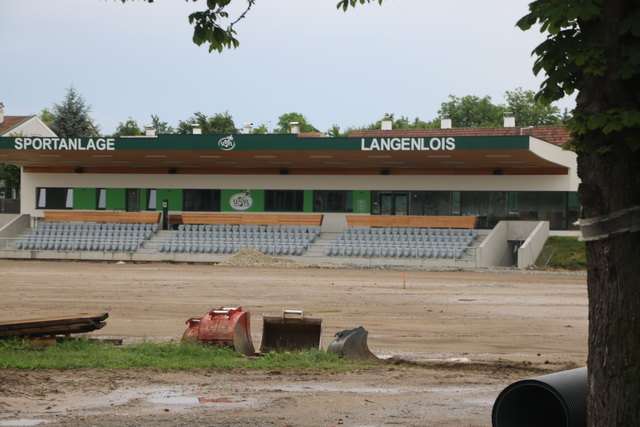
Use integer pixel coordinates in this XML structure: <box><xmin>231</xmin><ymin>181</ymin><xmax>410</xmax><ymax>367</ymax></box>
<box><xmin>536</xmin><ymin>236</ymin><xmax>587</xmax><ymax>270</ymax></box>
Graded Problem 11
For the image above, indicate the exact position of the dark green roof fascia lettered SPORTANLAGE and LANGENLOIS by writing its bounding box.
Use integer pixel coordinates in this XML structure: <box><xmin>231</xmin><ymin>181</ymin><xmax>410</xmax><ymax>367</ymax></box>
<box><xmin>0</xmin><ymin>134</ymin><xmax>530</xmax><ymax>151</ymax></box>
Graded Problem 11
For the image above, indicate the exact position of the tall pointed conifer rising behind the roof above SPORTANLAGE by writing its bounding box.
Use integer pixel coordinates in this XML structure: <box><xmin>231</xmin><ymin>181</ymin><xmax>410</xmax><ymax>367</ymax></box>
<box><xmin>50</xmin><ymin>87</ymin><xmax>98</xmax><ymax>138</ymax></box>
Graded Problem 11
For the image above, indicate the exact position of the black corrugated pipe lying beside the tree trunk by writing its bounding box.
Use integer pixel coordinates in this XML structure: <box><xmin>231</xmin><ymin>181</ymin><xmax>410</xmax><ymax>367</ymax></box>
<box><xmin>491</xmin><ymin>368</ymin><xmax>588</xmax><ymax>427</ymax></box>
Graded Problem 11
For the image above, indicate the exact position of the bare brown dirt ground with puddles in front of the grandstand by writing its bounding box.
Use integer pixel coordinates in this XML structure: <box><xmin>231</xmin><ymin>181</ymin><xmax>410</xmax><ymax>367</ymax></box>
<box><xmin>0</xmin><ymin>260</ymin><xmax>587</xmax><ymax>427</ymax></box>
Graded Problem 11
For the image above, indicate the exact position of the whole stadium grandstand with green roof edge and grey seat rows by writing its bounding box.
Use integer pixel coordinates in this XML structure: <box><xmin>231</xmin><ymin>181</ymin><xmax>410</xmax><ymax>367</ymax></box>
<box><xmin>0</xmin><ymin>113</ymin><xmax>580</xmax><ymax>268</ymax></box>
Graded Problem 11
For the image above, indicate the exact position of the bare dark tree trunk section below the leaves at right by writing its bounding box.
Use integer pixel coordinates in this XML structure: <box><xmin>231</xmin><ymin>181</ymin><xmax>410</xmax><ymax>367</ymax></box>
<box><xmin>578</xmin><ymin>145</ymin><xmax>640</xmax><ymax>427</ymax></box>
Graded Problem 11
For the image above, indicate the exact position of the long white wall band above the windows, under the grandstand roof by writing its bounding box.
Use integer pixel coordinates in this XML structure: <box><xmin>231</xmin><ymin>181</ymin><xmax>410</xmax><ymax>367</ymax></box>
<box><xmin>21</xmin><ymin>171</ymin><xmax>576</xmax><ymax>215</ymax></box>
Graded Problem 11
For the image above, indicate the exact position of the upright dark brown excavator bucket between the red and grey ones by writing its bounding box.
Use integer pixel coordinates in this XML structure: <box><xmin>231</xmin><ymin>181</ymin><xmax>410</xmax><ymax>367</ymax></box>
<box><xmin>260</xmin><ymin>310</ymin><xmax>322</xmax><ymax>353</ymax></box>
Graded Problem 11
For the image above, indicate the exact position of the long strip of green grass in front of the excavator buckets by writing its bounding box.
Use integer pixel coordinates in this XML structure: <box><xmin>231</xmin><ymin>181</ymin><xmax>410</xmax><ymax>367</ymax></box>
<box><xmin>0</xmin><ymin>340</ymin><xmax>372</xmax><ymax>372</ymax></box>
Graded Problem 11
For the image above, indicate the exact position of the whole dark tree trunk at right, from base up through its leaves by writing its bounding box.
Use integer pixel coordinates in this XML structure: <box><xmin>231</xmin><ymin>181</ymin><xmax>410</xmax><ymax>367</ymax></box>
<box><xmin>576</xmin><ymin>0</ymin><xmax>640</xmax><ymax>427</ymax></box>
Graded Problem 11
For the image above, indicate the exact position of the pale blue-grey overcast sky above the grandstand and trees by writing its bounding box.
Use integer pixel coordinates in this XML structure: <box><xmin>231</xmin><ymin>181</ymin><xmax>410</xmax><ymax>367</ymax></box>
<box><xmin>0</xmin><ymin>0</ymin><xmax>575</xmax><ymax>134</ymax></box>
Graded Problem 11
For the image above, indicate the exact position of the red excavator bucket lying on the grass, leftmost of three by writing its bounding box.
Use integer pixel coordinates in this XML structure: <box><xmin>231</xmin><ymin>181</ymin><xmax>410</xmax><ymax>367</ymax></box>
<box><xmin>182</xmin><ymin>307</ymin><xmax>255</xmax><ymax>356</ymax></box>
